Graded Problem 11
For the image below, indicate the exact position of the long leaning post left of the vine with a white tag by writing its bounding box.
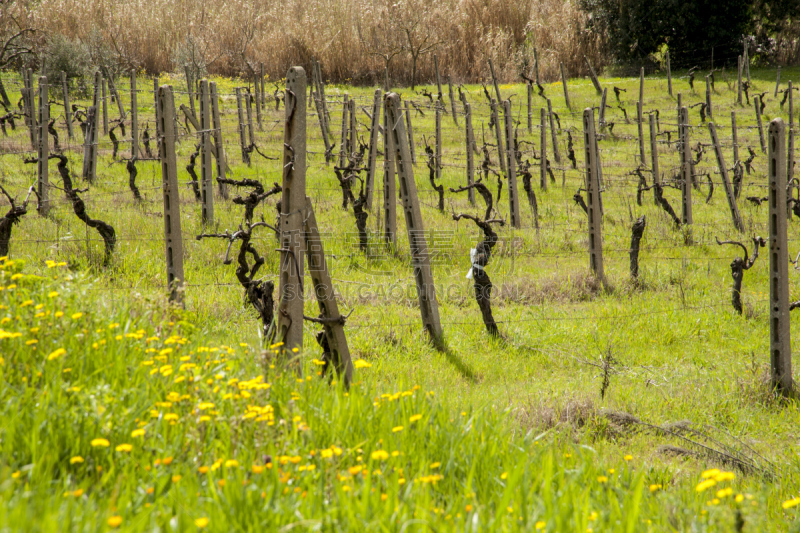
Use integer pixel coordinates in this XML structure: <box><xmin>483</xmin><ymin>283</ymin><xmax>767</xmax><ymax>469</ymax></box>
<box><xmin>384</xmin><ymin>93</ymin><xmax>443</xmax><ymax>344</ymax></box>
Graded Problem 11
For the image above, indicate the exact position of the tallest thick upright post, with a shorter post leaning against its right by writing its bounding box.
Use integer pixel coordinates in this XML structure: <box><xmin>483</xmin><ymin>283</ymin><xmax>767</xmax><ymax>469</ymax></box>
<box><xmin>277</xmin><ymin>67</ymin><xmax>309</xmax><ymax>353</ymax></box>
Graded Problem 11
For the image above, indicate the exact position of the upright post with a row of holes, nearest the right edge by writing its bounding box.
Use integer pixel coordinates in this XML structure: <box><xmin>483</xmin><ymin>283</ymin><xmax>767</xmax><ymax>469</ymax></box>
<box><xmin>768</xmin><ymin>118</ymin><xmax>793</xmax><ymax>395</ymax></box>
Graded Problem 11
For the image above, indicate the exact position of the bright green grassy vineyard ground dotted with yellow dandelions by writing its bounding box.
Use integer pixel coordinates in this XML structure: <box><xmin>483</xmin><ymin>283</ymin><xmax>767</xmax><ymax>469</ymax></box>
<box><xmin>0</xmin><ymin>65</ymin><xmax>800</xmax><ymax>532</ymax></box>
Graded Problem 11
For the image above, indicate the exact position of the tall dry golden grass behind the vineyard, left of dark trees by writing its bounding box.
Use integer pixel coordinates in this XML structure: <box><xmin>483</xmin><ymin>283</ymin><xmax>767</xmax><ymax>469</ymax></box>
<box><xmin>27</xmin><ymin>0</ymin><xmax>606</xmax><ymax>83</ymax></box>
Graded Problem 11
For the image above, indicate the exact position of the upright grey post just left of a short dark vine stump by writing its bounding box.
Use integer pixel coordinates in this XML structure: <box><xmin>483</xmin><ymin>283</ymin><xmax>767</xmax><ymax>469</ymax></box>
<box><xmin>583</xmin><ymin>107</ymin><xmax>605</xmax><ymax>283</ymax></box>
